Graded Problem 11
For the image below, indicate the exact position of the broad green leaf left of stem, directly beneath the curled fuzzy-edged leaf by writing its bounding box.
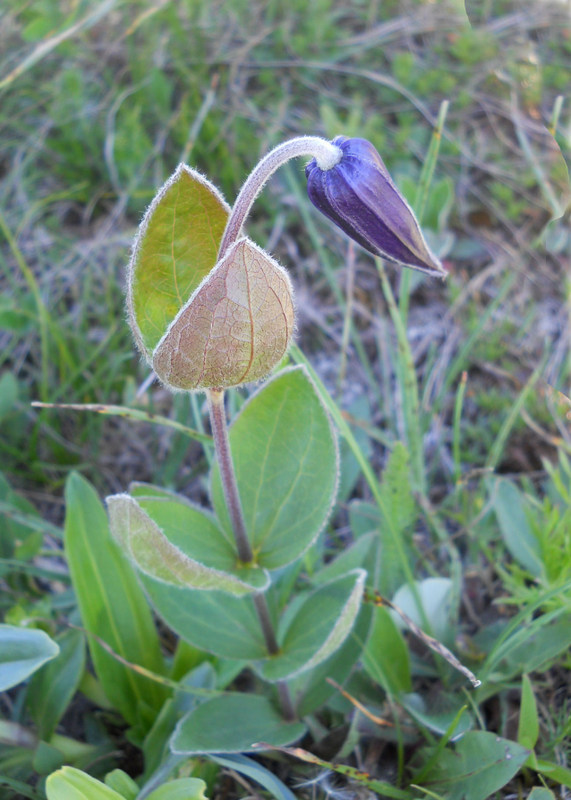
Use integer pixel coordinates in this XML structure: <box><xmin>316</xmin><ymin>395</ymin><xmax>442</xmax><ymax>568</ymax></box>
<box><xmin>141</xmin><ymin>575</ymin><xmax>267</xmax><ymax>661</ymax></box>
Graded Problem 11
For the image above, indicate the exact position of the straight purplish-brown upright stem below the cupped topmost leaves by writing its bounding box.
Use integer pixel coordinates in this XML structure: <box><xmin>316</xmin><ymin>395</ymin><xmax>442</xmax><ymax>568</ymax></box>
<box><xmin>207</xmin><ymin>389</ymin><xmax>295</xmax><ymax>720</ymax></box>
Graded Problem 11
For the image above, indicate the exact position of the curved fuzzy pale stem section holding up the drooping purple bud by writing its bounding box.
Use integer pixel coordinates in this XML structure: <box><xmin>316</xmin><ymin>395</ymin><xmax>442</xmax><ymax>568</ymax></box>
<box><xmin>218</xmin><ymin>136</ymin><xmax>342</xmax><ymax>261</ymax></box>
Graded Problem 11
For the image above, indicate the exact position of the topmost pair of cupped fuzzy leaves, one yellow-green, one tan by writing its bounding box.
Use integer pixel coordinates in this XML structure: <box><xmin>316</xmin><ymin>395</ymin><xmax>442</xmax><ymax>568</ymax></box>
<box><xmin>127</xmin><ymin>164</ymin><xmax>294</xmax><ymax>390</ymax></box>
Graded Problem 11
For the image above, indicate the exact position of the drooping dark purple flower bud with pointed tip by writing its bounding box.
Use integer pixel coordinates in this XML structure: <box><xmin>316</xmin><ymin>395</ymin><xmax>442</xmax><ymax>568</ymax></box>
<box><xmin>305</xmin><ymin>136</ymin><xmax>446</xmax><ymax>277</ymax></box>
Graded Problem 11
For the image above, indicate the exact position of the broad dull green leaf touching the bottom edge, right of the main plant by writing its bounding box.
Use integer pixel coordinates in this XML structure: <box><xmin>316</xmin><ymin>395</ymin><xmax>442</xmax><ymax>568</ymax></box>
<box><xmin>423</xmin><ymin>731</ymin><xmax>529</xmax><ymax>800</ymax></box>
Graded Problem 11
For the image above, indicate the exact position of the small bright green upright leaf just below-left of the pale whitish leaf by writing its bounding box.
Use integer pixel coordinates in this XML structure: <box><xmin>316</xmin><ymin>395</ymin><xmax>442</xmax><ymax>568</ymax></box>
<box><xmin>363</xmin><ymin>606</ymin><xmax>412</xmax><ymax>695</ymax></box>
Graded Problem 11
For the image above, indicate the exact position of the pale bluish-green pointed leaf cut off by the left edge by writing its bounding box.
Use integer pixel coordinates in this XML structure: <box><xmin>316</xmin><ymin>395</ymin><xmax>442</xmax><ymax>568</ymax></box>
<box><xmin>0</xmin><ymin>625</ymin><xmax>59</xmax><ymax>692</ymax></box>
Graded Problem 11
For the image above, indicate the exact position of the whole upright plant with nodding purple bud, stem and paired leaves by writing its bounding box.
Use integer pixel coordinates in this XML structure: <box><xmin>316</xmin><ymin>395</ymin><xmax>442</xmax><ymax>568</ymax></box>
<box><xmin>108</xmin><ymin>136</ymin><xmax>444</xmax><ymax>752</ymax></box>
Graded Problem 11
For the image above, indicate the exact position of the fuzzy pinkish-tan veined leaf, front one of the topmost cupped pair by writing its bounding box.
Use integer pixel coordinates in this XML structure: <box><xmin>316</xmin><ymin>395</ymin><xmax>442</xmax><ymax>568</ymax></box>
<box><xmin>153</xmin><ymin>239</ymin><xmax>294</xmax><ymax>390</ymax></box>
